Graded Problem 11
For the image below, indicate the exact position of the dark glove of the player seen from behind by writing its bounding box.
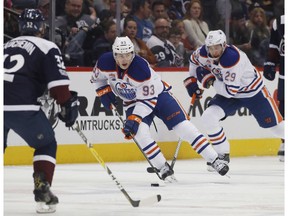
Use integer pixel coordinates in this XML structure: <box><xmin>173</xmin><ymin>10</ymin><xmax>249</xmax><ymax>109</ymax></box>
<box><xmin>58</xmin><ymin>91</ymin><xmax>79</xmax><ymax>127</ymax></box>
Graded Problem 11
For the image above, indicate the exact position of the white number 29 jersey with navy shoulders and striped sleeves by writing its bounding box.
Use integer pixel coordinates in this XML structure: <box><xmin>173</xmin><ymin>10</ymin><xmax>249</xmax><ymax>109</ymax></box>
<box><xmin>189</xmin><ymin>45</ymin><xmax>264</xmax><ymax>98</ymax></box>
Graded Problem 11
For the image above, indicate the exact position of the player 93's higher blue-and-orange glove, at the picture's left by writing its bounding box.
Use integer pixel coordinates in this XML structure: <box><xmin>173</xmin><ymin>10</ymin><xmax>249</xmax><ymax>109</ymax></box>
<box><xmin>96</xmin><ymin>85</ymin><xmax>117</xmax><ymax>110</ymax></box>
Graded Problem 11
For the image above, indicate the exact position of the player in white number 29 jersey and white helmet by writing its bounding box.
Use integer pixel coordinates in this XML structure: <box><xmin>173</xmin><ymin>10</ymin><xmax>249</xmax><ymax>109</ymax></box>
<box><xmin>184</xmin><ymin>30</ymin><xmax>284</xmax><ymax>169</ymax></box>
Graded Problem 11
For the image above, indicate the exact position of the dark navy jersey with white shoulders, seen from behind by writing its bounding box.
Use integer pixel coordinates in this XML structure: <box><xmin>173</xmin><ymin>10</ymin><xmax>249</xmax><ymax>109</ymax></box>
<box><xmin>4</xmin><ymin>36</ymin><xmax>70</xmax><ymax>111</ymax></box>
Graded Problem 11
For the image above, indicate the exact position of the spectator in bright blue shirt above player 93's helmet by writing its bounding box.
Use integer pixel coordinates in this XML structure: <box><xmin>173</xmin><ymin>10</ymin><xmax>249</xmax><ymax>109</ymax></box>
<box><xmin>131</xmin><ymin>0</ymin><xmax>153</xmax><ymax>42</ymax></box>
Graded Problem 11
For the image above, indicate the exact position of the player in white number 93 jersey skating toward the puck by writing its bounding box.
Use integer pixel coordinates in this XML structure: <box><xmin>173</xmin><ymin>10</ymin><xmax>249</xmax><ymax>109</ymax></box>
<box><xmin>92</xmin><ymin>37</ymin><xmax>229</xmax><ymax>182</ymax></box>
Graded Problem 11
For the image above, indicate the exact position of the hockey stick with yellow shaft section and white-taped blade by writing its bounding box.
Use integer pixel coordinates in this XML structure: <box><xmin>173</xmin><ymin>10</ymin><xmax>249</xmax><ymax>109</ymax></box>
<box><xmin>72</xmin><ymin>122</ymin><xmax>161</xmax><ymax>207</ymax></box>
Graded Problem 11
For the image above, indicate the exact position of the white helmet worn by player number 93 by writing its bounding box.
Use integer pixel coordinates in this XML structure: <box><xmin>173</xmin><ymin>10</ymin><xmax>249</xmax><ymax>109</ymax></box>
<box><xmin>112</xmin><ymin>36</ymin><xmax>135</xmax><ymax>59</ymax></box>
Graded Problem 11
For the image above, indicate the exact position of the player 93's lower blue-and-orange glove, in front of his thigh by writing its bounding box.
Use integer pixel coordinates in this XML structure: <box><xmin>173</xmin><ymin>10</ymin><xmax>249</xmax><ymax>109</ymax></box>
<box><xmin>122</xmin><ymin>114</ymin><xmax>142</xmax><ymax>140</ymax></box>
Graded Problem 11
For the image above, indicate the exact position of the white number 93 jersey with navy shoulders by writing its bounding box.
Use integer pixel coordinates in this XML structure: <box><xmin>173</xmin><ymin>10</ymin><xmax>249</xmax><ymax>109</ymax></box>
<box><xmin>92</xmin><ymin>52</ymin><xmax>169</xmax><ymax>117</ymax></box>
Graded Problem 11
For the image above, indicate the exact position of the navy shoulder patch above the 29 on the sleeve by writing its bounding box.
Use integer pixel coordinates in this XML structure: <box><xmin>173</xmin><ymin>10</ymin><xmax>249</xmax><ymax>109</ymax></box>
<box><xmin>220</xmin><ymin>46</ymin><xmax>240</xmax><ymax>68</ymax></box>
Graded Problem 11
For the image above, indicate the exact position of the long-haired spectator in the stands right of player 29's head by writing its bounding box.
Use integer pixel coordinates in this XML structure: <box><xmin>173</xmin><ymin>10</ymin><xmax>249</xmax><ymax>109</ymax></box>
<box><xmin>247</xmin><ymin>7</ymin><xmax>270</xmax><ymax>66</ymax></box>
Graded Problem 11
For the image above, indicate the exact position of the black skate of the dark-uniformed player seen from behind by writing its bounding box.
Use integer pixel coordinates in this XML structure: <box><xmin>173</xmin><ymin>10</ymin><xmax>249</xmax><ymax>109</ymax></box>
<box><xmin>33</xmin><ymin>173</ymin><xmax>59</xmax><ymax>213</ymax></box>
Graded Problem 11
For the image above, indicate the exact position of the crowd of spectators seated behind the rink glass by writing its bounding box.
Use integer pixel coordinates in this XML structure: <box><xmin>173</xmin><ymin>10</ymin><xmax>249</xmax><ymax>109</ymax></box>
<box><xmin>4</xmin><ymin>0</ymin><xmax>284</xmax><ymax>67</ymax></box>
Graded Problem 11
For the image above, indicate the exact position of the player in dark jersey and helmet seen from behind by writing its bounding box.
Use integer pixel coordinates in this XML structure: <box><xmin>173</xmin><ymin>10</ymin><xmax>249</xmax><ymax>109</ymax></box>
<box><xmin>4</xmin><ymin>9</ymin><xmax>78</xmax><ymax>213</ymax></box>
